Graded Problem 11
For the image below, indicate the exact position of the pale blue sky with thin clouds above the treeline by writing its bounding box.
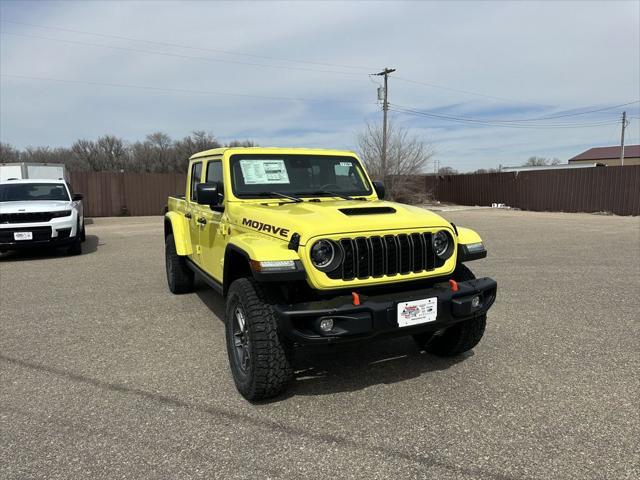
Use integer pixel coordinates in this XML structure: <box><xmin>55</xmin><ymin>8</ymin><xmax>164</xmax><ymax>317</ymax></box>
<box><xmin>0</xmin><ymin>0</ymin><xmax>640</xmax><ymax>171</ymax></box>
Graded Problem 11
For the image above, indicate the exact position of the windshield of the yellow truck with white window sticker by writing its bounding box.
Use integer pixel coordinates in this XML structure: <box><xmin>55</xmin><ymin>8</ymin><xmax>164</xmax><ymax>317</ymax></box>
<box><xmin>231</xmin><ymin>154</ymin><xmax>372</xmax><ymax>198</ymax></box>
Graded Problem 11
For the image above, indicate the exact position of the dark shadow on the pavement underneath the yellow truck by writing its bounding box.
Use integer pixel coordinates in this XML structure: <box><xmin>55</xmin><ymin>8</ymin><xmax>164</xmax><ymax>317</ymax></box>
<box><xmin>196</xmin><ymin>284</ymin><xmax>473</xmax><ymax>404</ymax></box>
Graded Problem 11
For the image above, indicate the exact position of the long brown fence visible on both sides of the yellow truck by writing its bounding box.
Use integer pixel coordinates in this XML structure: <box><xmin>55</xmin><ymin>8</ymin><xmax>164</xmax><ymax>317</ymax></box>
<box><xmin>71</xmin><ymin>165</ymin><xmax>640</xmax><ymax>217</ymax></box>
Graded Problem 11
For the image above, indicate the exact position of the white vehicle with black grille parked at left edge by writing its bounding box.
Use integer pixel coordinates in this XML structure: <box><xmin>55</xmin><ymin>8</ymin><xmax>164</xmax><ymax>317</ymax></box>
<box><xmin>0</xmin><ymin>179</ymin><xmax>85</xmax><ymax>255</ymax></box>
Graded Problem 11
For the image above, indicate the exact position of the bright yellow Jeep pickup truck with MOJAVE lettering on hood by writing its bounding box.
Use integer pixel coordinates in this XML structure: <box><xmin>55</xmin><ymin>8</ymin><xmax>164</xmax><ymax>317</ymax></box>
<box><xmin>164</xmin><ymin>148</ymin><xmax>496</xmax><ymax>400</ymax></box>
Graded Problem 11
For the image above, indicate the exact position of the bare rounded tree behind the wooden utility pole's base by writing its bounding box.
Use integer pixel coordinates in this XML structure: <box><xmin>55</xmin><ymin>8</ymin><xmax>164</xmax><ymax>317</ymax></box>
<box><xmin>358</xmin><ymin>122</ymin><xmax>435</xmax><ymax>203</ymax></box>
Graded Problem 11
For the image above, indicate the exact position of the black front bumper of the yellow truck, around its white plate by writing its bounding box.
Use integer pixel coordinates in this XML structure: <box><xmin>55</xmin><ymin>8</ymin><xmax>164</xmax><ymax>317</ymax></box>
<box><xmin>275</xmin><ymin>278</ymin><xmax>497</xmax><ymax>345</ymax></box>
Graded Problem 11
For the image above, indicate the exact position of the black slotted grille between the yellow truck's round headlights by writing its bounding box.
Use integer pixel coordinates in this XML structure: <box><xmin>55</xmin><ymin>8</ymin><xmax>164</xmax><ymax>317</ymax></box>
<box><xmin>327</xmin><ymin>232</ymin><xmax>444</xmax><ymax>280</ymax></box>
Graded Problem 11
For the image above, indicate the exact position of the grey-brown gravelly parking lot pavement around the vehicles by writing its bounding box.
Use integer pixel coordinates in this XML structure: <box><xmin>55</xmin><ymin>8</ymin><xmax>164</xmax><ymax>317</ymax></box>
<box><xmin>0</xmin><ymin>210</ymin><xmax>640</xmax><ymax>480</ymax></box>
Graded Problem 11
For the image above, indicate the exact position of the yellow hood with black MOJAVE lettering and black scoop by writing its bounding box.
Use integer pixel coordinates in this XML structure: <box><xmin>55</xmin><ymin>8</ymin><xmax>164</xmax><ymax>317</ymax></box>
<box><xmin>227</xmin><ymin>200</ymin><xmax>451</xmax><ymax>245</ymax></box>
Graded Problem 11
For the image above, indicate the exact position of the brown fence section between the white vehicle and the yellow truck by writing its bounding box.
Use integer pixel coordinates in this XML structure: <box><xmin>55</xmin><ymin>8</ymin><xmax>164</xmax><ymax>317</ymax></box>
<box><xmin>70</xmin><ymin>172</ymin><xmax>186</xmax><ymax>217</ymax></box>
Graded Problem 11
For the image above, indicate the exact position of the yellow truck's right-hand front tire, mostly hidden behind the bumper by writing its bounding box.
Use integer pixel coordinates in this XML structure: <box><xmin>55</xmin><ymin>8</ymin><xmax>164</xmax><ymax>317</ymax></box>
<box><xmin>413</xmin><ymin>264</ymin><xmax>487</xmax><ymax>357</ymax></box>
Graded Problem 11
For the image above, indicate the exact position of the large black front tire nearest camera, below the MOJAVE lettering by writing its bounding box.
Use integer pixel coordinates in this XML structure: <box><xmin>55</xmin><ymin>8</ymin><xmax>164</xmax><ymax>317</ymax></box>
<box><xmin>225</xmin><ymin>278</ymin><xmax>293</xmax><ymax>401</ymax></box>
